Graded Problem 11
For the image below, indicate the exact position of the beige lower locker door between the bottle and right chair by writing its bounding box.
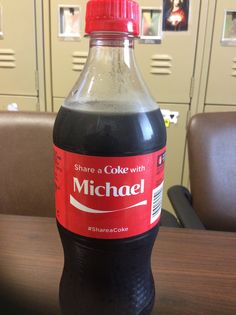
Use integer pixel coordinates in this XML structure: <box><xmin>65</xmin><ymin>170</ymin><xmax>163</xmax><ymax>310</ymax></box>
<box><xmin>160</xmin><ymin>104</ymin><xmax>189</xmax><ymax>211</ymax></box>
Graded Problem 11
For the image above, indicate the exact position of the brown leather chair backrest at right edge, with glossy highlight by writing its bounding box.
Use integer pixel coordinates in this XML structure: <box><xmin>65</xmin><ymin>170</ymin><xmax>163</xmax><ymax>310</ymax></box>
<box><xmin>188</xmin><ymin>112</ymin><xmax>236</xmax><ymax>231</ymax></box>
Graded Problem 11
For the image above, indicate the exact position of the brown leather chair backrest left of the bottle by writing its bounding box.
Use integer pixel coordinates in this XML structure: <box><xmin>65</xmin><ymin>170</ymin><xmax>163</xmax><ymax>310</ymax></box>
<box><xmin>0</xmin><ymin>112</ymin><xmax>55</xmax><ymax>216</ymax></box>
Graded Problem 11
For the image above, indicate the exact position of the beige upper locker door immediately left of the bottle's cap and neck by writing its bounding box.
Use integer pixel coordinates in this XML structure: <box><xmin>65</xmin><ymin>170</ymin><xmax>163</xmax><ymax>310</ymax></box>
<box><xmin>50</xmin><ymin>0</ymin><xmax>88</xmax><ymax>98</ymax></box>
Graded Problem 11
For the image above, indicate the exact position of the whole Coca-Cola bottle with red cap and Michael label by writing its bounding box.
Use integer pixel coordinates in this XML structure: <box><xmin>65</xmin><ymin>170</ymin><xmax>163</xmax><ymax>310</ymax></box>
<box><xmin>53</xmin><ymin>0</ymin><xmax>166</xmax><ymax>315</ymax></box>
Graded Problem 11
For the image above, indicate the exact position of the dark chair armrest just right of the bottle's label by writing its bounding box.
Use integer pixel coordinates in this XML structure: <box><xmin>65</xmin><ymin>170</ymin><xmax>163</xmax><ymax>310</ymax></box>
<box><xmin>167</xmin><ymin>185</ymin><xmax>205</xmax><ymax>230</ymax></box>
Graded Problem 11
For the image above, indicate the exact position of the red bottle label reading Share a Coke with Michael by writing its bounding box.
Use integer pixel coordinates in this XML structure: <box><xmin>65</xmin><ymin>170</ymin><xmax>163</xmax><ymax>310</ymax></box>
<box><xmin>54</xmin><ymin>146</ymin><xmax>165</xmax><ymax>239</ymax></box>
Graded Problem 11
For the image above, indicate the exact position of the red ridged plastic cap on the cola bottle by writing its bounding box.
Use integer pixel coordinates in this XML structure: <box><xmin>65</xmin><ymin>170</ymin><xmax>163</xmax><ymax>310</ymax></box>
<box><xmin>85</xmin><ymin>0</ymin><xmax>139</xmax><ymax>36</ymax></box>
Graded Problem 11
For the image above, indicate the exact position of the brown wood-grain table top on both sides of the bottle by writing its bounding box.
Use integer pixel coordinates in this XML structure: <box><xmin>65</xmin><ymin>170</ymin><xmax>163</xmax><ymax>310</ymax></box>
<box><xmin>0</xmin><ymin>215</ymin><xmax>236</xmax><ymax>315</ymax></box>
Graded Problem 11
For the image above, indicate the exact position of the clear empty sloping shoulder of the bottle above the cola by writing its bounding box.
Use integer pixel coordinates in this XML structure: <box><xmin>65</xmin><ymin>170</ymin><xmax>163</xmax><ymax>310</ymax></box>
<box><xmin>64</xmin><ymin>46</ymin><xmax>158</xmax><ymax>112</ymax></box>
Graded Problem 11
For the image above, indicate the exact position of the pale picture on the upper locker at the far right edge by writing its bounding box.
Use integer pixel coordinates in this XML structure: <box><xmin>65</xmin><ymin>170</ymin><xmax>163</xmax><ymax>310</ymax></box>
<box><xmin>222</xmin><ymin>9</ymin><xmax>236</xmax><ymax>46</ymax></box>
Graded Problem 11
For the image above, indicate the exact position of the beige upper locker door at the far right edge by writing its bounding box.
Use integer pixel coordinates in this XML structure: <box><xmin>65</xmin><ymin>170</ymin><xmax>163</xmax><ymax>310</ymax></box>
<box><xmin>206</xmin><ymin>0</ymin><xmax>236</xmax><ymax>105</ymax></box>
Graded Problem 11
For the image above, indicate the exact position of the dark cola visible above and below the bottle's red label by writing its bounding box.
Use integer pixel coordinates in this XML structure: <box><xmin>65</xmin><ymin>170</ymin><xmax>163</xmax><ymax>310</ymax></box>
<box><xmin>53</xmin><ymin>107</ymin><xmax>166</xmax><ymax>315</ymax></box>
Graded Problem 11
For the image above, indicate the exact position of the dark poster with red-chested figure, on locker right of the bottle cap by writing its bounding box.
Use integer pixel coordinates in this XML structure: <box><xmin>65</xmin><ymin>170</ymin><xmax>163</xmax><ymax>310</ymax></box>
<box><xmin>162</xmin><ymin>0</ymin><xmax>189</xmax><ymax>32</ymax></box>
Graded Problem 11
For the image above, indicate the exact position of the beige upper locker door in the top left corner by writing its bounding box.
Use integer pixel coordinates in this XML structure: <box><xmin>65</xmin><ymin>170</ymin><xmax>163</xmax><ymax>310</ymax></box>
<box><xmin>0</xmin><ymin>0</ymin><xmax>37</xmax><ymax>96</ymax></box>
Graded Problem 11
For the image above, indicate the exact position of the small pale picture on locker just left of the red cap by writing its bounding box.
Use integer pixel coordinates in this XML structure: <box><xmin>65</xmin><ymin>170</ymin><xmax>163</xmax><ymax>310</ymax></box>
<box><xmin>58</xmin><ymin>5</ymin><xmax>81</xmax><ymax>39</ymax></box>
